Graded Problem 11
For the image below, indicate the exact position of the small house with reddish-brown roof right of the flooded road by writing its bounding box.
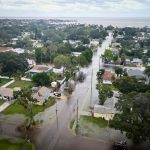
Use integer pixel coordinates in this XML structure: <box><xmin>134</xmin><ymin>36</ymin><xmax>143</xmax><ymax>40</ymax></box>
<box><xmin>102</xmin><ymin>71</ymin><xmax>114</xmax><ymax>84</ymax></box>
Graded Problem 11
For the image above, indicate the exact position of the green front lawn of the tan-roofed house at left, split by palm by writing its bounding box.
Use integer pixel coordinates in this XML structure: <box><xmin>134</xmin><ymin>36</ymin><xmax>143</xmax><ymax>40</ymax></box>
<box><xmin>2</xmin><ymin>99</ymin><xmax>55</xmax><ymax>116</ymax></box>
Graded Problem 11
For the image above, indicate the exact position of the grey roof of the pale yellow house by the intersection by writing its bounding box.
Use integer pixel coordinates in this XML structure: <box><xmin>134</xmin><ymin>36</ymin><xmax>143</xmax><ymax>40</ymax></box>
<box><xmin>94</xmin><ymin>105</ymin><xmax>116</xmax><ymax>114</ymax></box>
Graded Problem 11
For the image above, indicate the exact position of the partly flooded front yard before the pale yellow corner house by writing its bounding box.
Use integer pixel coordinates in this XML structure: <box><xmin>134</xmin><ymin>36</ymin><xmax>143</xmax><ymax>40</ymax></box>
<box><xmin>76</xmin><ymin>116</ymin><xmax>126</xmax><ymax>142</ymax></box>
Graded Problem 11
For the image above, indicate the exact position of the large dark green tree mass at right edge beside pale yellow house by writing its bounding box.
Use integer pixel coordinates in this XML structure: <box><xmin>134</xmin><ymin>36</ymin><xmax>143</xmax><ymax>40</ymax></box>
<box><xmin>110</xmin><ymin>92</ymin><xmax>150</xmax><ymax>143</ymax></box>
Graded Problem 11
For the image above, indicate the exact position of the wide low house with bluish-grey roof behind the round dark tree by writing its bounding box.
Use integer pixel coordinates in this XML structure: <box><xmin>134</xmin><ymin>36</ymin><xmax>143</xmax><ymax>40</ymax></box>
<box><xmin>29</xmin><ymin>65</ymin><xmax>53</xmax><ymax>75</ymax></box>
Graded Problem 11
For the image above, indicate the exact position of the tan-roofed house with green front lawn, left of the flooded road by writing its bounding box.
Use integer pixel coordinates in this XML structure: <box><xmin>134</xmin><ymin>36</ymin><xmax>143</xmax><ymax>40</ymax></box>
<box><xmin>32</xmin><ymin>86</ymin><xmax>51</xmax><ymax>105</ymax></box>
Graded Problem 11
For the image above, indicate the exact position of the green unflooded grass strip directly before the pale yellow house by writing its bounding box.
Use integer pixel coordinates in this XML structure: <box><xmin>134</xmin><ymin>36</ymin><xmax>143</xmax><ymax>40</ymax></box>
<box><xmin>81</xmin><ymin>116</ymin><xmax>107</xmax><ymax>128</ymax></box>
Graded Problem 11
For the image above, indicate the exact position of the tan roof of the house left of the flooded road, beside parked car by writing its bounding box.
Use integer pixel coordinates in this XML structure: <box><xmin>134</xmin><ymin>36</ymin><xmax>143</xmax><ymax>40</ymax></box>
<box><xmin>33</xmin><ymin>86</ymin><xmax>51</xmax><ymax>102</ymax></box>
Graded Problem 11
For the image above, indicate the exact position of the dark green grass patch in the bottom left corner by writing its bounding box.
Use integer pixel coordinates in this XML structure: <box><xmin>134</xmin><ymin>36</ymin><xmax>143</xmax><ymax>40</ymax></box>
<box><xmin>0</xmin><ymin>139</ymin><xmax>33</xmax><ymax>150</ymax></box>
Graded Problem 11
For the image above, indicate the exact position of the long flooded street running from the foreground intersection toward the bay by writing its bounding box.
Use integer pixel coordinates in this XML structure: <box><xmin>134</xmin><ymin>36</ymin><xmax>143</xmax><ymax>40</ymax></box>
<box><xmin>31</xmin><ymin>34</ymin><xmax>112</xmax><ymax>150</ymax></box>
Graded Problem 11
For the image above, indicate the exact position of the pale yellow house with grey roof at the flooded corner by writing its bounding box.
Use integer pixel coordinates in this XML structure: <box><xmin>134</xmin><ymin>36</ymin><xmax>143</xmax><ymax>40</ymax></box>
<box><xmin>93</xmin><ymin>105</ymin><xmax>116</xmax><ymax>120</ymax></box>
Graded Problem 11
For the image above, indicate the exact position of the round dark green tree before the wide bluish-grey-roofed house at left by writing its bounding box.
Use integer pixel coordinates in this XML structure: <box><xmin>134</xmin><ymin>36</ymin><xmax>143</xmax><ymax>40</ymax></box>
<box><xmin>32</xmin><ymin>72</ymin><xmax>50</xmax><ymax>86</ymax></box>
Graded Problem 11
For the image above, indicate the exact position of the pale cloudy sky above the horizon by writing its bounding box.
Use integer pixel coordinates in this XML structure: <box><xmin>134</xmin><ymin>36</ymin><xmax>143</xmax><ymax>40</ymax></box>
<box><xmin>0</xmin><ymin>0</ymin><xmax>150</xmax><ymax>17</ymax></box>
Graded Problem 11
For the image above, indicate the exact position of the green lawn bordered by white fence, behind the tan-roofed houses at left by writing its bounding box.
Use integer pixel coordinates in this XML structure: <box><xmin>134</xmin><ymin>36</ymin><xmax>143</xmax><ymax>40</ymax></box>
<box><xmin>8</xmin><ymin>80</ymin><xmax>34</xmax><ymax>88</ymax></box>
